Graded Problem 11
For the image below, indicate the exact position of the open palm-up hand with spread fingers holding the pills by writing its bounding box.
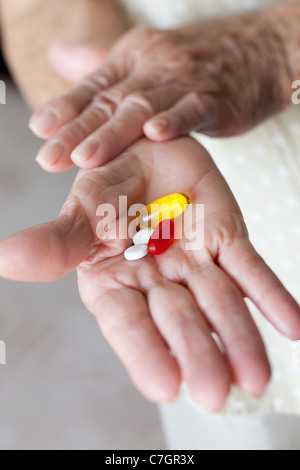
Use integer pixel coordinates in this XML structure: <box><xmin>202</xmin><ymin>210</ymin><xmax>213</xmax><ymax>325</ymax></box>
<box><xmin>0</xmin><ymin>138</ymin><xmax>300</xmax><ymax>410</ymax></box>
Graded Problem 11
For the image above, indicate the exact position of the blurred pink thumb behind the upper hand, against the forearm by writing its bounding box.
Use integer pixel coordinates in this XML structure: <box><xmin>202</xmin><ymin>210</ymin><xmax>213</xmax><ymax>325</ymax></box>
<box><xmin>48</xmin><ymin>43</ymin><xmax>110</xmax><ymax>83</ymax></box>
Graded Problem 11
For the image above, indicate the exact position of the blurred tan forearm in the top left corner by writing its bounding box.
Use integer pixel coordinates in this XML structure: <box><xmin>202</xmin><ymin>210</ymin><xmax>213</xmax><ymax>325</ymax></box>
<box><xmin>0</xmin><ymin>0</ymin><xmax>129</xmax><ymax>108</ymax></box>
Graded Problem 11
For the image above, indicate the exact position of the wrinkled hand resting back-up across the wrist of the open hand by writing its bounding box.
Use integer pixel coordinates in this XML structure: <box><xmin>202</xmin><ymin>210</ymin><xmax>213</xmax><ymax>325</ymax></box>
<box><xmin>31</xmin><ymin>2</ymin><xmax>299</xmax><ymax>172</ymax></box>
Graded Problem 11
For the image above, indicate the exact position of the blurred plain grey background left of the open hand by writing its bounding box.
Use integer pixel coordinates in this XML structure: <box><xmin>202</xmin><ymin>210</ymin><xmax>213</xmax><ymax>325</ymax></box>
<box><xmin>0</xmin><ymin>59</ymin><xmax>164</xmax><ymax>450</ymax></box>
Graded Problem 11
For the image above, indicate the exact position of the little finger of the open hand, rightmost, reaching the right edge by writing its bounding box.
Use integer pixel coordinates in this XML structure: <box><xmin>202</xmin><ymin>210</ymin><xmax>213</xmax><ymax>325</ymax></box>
<box><xmin>219</xmin><ymin>239</ymin><xmax>300</xmax><ymax>341</ymax></box>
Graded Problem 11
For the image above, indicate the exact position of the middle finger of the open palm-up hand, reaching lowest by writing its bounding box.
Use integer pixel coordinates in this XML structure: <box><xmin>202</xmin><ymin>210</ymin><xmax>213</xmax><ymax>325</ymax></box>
<box><xmin>148</xmin><ymin>284</ymin><xmax>231</xmax><ymax>411</ymax></box>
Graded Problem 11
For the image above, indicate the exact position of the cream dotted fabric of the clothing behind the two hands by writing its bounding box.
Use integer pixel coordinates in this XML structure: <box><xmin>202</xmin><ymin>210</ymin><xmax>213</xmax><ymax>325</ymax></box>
<box><xmin>118</xmin><ymin>0</ymin><xmax>300</xmax><ymax>415</ymax></box>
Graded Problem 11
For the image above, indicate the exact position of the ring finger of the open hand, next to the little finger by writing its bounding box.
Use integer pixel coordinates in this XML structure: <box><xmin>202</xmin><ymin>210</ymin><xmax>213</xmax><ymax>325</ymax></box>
<box><xmin>187</xmin><ymin>262</ymin><xmax>270</xmax><ymax>397</ymax></box>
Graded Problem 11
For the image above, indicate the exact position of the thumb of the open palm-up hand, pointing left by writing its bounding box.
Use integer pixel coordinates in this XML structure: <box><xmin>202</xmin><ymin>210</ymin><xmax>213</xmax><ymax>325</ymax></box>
<box><xmin>0</xmin><ymin>205</ymin><xmax>95</xmax><ymax>282</ymax></box>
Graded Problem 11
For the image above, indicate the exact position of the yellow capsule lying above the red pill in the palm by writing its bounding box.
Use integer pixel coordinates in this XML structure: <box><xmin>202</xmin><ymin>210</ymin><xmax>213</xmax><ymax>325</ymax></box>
<box><xmin>136</xmin><ymin>193</ymin><xmax>191</xmax><ymax>229</ymax></box>
